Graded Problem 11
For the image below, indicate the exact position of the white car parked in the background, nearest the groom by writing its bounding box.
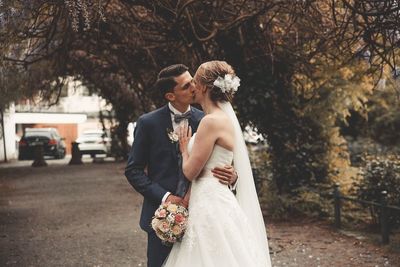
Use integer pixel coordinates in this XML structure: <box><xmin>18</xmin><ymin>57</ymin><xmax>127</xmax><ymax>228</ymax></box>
<box><xmin>76</xmin><ymin>130</ymin><xmax>111</xmax><ymax>158</ymax></box>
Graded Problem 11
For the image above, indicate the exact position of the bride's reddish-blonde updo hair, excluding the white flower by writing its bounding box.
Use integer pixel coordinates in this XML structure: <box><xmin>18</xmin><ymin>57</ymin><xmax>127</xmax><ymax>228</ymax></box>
<box><xmin>195</xmin><ymin>60</ymin><xmax>235</xmax><ymax>102</ymax></box>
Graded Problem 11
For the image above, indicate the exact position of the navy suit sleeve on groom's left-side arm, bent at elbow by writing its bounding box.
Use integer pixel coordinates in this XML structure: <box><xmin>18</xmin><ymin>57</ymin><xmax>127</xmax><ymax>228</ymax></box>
<box><xmin>125</xmin><ymin>117</ymin><xmax>168</xmax><ymax>203</ymax></box>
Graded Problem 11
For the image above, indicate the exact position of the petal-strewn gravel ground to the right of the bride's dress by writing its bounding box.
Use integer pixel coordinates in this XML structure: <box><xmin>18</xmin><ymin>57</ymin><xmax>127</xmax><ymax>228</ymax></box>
<box><xmin>267</xmin><ymin>219</ymin><xmax>400</xmax><ymax>267</ymax></box>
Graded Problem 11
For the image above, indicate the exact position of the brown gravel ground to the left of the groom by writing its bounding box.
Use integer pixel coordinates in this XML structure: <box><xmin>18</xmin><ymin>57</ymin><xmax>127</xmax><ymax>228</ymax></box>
<box><xmin>0</xmin><ymin>163</ymin><xmax>146</xmax><ymax>266</ymax></box>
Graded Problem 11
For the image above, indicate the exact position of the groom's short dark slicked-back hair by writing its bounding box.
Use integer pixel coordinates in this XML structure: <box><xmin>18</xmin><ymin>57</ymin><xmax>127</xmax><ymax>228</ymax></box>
<box><xmin>155</xmin><ymin>64</ymin><xmax>189</xmax><ymax>97</ymax></box>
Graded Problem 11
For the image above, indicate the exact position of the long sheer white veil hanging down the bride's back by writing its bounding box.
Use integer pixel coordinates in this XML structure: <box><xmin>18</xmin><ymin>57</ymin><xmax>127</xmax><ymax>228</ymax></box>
<box><xmin>218</xmin><ymin>102</ymin><xmax>271</xmax><ymax>262</ymax></box>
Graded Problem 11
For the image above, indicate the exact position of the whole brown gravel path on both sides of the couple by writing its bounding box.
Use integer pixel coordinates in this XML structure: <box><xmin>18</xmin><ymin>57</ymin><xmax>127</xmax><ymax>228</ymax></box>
<box><xmin>0</xmin><ymin>162</ymin><xmax>400</xmax><ymax>267</ymax></box>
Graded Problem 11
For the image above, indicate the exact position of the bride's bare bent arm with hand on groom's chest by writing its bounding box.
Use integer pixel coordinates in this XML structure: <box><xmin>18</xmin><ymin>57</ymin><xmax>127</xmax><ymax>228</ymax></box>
<box><xmin>179</xmin><ymin>116</ymin><xmax>218</xmax><ymax>181</ymax></box>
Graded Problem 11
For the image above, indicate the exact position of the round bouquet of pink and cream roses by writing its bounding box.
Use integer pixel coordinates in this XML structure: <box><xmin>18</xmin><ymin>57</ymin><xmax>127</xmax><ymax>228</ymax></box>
<box><xmin>151</xmin><ymin>202</ymin><xmax>189</xmax><ymax>245</ymax></box>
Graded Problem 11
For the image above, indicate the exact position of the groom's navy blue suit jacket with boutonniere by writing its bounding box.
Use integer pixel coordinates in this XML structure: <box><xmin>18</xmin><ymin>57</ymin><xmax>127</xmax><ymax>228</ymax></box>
<box><xmin>125</xmin><ymin>105</ymin><xmax>204</xmax><ymax>232</ymax></box>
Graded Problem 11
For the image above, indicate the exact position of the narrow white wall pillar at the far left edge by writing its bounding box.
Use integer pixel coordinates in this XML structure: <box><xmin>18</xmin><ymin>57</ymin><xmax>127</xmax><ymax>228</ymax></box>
<box><xmin>0</xmin><ymin>104</ymin><xmax>17</xmax><ymax>161</ymax></box>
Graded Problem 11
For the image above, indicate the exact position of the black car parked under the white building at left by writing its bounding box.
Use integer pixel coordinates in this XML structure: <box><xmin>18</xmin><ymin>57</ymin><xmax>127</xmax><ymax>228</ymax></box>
<box><xmin>18</xmin><ymin>128</ymin><xmax>65</xmax><ymax>160</ymax></box>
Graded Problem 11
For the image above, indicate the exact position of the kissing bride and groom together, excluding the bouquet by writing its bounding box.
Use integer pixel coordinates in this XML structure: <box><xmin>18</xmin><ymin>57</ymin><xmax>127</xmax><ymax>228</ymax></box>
<box><xmin>125</xmin><ymin>61</ymin><xmax>271</xmax><ymax>267</ymax></box>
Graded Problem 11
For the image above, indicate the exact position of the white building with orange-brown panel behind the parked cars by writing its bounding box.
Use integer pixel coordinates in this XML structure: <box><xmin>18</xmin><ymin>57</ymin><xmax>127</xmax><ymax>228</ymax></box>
<box><xmin>0</xmin><ymin>78</ymin><xmax>111</xmax><ymax>162</ymax></box>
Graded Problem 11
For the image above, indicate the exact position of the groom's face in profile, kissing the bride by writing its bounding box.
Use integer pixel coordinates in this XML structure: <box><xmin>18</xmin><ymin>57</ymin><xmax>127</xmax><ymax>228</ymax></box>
<box><xmin>173</xmin><ymin>71</ymin><xmax>194</xmax><ymax>106</ymax></box>
